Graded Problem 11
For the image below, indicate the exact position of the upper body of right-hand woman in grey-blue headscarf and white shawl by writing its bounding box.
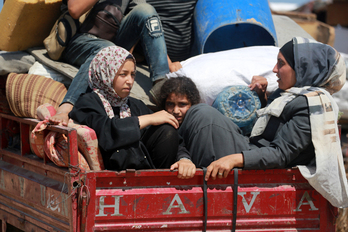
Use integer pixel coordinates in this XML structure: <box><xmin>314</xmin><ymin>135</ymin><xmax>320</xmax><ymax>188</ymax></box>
<box><xmin>206</xmin><ymin>37</ymin><xmax>348</xmax><ymax>207</ymax></box>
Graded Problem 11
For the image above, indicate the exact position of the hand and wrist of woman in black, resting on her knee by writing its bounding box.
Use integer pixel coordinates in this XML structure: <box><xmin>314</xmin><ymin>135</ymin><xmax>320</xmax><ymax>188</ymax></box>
<box><xmin>138</xmin><ymin>110</ymin><xmax>179</xmax><ymax>129</ymax></box>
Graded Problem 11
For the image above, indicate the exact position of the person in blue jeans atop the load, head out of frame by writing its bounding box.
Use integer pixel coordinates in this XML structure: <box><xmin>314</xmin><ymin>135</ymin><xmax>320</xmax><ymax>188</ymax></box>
<box><xmin>49</xmin><ymin>0</ymin><xmax>169</xmax><ymax>126</ymax></box>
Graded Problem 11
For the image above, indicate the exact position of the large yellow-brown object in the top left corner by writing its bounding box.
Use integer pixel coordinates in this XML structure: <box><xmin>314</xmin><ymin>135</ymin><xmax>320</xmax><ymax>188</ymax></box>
<box><xmin>0</xmin><ymin>0</ymin><xmax>62</xmax><ymax>51</ymax></box>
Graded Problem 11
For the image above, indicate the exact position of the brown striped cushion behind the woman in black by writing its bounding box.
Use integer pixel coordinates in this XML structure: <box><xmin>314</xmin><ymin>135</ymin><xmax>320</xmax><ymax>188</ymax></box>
<box><xmin>6</xmin><ymin>73</ymin><xmax>67</xmax><ymax>118</ymax></box>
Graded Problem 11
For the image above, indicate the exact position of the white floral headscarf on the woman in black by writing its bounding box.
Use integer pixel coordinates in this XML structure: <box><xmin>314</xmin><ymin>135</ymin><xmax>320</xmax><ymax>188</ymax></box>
<box><xmin>88</xmin><ymin>46</ymin><xmax>136</xmax><ymax>118</ymax></box>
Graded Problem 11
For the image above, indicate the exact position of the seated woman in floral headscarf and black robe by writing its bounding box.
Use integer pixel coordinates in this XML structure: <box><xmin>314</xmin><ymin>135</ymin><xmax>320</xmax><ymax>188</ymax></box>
<box><xmin>69</xmin><ymin>46</ymin><xmax>194</xmax><ymax>177</ymax></box>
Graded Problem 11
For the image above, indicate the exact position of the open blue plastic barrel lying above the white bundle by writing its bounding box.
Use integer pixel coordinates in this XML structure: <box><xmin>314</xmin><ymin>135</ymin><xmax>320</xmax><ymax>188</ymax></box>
<box><xmin>194</xmin><ymin>0</ymin><xmax>278</xmax><ymax>54</ymax></box>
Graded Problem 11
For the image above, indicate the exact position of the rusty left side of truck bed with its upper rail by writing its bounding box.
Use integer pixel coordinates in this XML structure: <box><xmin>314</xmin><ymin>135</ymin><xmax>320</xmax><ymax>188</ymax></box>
<box><xmin>0</xmin><ymin>114</ymin><xmax>81</xmax><ymax>231</ymax></box>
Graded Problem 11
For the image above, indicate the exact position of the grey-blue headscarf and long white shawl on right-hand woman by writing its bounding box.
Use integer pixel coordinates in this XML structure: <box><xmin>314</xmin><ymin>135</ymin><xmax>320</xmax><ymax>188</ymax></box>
<box><xmin>251</xmin><ymin>37</ymin><xmax>348</xmax><ymax>207</ymax></box>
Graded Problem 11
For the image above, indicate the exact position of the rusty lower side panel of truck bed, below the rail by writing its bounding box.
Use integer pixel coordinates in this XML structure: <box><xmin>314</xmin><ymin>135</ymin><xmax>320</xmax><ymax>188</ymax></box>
<box><xmin>0</xmin><ymin>161</ymin><xmax>71</xmax><ymax>231</ymax></box>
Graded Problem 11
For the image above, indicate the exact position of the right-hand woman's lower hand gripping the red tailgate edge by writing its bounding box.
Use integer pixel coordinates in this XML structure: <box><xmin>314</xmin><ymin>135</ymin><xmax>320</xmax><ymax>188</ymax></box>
<box><xmin>205</xmin><ymin>153</ymin><xmax>244</xmax><ymax>181</ymax></box>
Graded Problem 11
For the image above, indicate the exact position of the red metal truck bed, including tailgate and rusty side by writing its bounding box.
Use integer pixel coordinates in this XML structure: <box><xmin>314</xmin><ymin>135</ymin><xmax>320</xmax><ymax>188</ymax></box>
<box><xmin>0</xmin><ymin>114</ymin><xmax>337</xmax><ymax>232</ymax></box>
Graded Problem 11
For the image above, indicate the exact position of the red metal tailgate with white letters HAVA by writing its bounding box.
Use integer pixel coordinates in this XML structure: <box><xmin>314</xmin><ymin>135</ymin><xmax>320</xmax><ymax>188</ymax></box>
<box><xmin>82</xmin><ymin>169</ymin><xmax>336</xmax><ymax>231</ymax></box>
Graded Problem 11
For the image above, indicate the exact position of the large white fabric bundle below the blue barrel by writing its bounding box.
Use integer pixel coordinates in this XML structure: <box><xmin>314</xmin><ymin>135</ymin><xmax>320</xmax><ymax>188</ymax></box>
<box><xmin>167</xmin><ymin>46</ymin><xmax>279</xmax><ymax>105</ymax></box>
